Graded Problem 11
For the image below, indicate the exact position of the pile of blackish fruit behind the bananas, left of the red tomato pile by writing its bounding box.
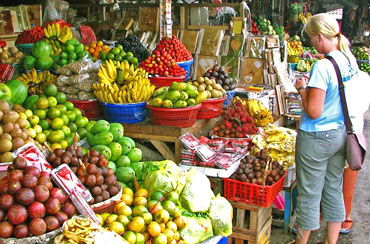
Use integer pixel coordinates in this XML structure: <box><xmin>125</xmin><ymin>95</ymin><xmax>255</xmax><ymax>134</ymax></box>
<box><xmin>117</xmin><ymin>35</ymin><xmax>150</xmax><ymax>62</ymax></box>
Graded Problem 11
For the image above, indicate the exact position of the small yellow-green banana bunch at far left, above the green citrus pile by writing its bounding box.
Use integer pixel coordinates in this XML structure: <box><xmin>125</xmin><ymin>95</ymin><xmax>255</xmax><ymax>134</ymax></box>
<box><xmin>17</xmin><ymin>69</ymin><xmax>57</xmax><ymax>95</ymax></box>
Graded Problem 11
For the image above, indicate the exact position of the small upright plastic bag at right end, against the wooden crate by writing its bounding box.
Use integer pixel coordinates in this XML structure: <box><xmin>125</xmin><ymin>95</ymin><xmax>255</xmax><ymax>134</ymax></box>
<box><xmin>209</xmin><ymin>195</ymin><xmax>233</xmax><ymax>236</ymax></box>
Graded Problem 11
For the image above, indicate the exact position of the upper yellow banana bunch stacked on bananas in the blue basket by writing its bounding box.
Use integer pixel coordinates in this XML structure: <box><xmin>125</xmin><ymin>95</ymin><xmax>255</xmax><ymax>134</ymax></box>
<box><xmin>98</xmin><ymin>59</ymin><xmax>148</xmax><ymax>85</ymax></box>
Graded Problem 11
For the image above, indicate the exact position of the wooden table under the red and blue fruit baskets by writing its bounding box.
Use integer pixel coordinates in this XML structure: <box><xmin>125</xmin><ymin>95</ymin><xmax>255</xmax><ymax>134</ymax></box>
<box><xmin>123</xmin><ymin>116</ymin><xmax>221</xmax><ymax>163</ymax></box>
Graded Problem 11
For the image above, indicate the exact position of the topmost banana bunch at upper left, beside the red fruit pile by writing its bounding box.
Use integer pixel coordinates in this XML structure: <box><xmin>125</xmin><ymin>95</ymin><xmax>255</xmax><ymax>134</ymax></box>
<box><xmin>44</xmin><ymin>22</ymin><xmax>73</xmax><ymax>55</ymax></box>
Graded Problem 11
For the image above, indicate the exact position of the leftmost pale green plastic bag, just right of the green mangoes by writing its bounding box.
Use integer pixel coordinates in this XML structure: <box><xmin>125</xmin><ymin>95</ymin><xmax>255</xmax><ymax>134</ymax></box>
<box><xmin>144</xmin><ymin>160</ymin><xmax>185</xmax><ymax>194</ymax></box>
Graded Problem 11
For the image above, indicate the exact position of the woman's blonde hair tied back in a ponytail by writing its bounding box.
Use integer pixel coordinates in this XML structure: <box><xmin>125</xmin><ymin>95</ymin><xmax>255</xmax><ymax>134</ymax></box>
<box><xmin>304</xmin><ymin>13</ymin><xmax>355</xmax><ymax>60</ymax></box>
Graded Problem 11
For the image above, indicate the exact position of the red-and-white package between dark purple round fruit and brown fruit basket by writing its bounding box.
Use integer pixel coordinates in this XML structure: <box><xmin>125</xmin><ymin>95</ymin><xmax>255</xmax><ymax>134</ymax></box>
<box><xmin>51</xmin><ymin>164</ymin><xmax>93</xmax><ymax>202</ymax></box>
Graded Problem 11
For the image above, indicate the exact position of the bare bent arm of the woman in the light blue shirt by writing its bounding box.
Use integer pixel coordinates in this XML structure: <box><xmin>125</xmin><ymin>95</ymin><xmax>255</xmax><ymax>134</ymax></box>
<box><xmin>295</xmin><ymin>78</ymin><xmax>326</xmax><ymax>119</ymax></box>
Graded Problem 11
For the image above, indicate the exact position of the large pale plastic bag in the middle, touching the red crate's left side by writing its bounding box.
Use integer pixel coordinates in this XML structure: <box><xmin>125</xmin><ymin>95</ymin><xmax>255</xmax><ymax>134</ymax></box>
<box><xmin>180</xmin><ymin>168</ymin><xmax>214</xmax><ymax>213</ymax></box>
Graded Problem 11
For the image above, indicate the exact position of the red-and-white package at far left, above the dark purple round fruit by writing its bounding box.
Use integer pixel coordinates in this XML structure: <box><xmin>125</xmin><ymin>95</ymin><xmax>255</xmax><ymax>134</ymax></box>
<box><xmin>13</xmin><ymin>142</ymin><xmax>53</xmax><ymax>173</ymax></box>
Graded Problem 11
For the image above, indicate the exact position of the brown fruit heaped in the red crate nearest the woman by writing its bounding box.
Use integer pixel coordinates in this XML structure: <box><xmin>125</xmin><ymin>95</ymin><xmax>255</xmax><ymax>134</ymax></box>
<box><xmin>230</xmin><ymin>149</ymin><xmax>285</xmax><ymax>186</ymax></box>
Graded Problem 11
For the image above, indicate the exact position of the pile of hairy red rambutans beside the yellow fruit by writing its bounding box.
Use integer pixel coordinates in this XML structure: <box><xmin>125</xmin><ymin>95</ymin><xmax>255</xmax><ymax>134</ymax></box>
<box><xmin>210</xmin><ymin>101</ymin><xmax>258</xmax><ymax>138</ymax></box>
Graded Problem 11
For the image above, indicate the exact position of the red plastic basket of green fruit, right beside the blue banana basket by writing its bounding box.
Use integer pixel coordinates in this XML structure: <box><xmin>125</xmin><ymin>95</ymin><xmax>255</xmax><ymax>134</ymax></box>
<box><xmin>146</xmin><ymin>104</ymin><xmax>200</xmax><ymax>127</ymax></box>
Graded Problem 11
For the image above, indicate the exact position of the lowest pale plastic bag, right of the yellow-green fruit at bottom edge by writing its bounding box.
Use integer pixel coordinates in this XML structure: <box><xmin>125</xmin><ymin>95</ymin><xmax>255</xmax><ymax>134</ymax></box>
<box><xmin>180</xmin><ymin>216</ymin><xmax>213</xmax><ymax>244</ymax></box>
